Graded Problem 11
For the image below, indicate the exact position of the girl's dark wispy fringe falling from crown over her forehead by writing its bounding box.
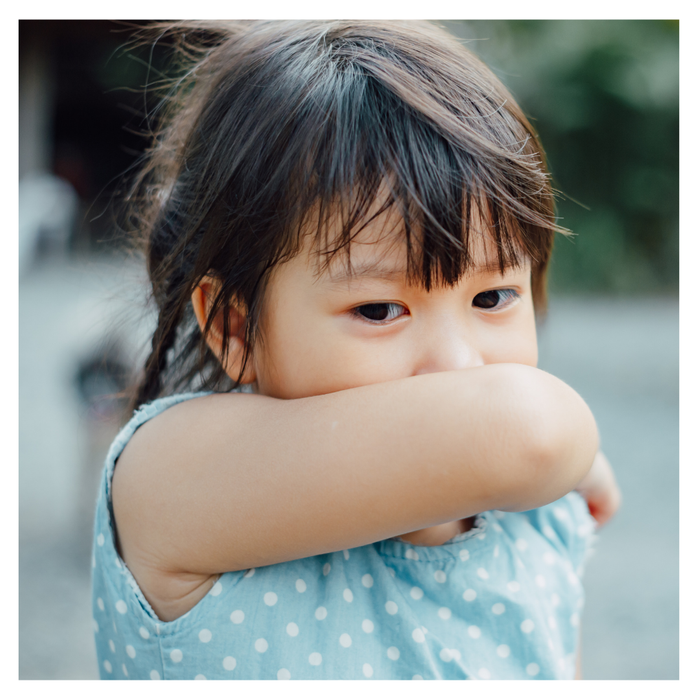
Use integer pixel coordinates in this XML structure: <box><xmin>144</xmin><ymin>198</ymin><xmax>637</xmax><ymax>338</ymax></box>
<box><xmin>258</xmin><ymin>29</ymin><xmax>558</xmax><ymax>290</ymax></box>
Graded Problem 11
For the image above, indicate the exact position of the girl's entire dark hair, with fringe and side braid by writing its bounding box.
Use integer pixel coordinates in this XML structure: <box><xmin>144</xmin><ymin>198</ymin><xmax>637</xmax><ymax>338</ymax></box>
<box><xmin>126</xmin><ymin>20</ymin><xmax>563</xmax><ymax>405</ymax></box>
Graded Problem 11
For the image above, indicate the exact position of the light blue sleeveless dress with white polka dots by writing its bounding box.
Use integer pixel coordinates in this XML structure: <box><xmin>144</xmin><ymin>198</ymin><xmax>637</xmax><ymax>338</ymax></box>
<box><xmin>92</xmin><ymin>394</ymin><xmax>594</xmax><ymax>680</ymax></box>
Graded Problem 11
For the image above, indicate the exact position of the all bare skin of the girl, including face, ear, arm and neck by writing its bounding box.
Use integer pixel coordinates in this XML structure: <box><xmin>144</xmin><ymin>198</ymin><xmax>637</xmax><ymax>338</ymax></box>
<box><xmin>113</xmin><ymin>208</ymin><xmax>610</xmax><ymax>640</ymax></box>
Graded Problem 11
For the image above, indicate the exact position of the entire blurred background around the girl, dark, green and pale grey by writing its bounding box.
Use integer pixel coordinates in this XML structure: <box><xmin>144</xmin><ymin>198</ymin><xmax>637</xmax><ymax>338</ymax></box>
<box><xmin>19</xmin><ymin>20</ymin><xmax>679</xmax><ymax>679</ymax></box>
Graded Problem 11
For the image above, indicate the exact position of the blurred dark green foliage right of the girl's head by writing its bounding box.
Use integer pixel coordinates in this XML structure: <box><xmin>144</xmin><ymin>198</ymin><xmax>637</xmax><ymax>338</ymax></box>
<box><xmin>443</xmin><ymin>20</ymin><xmax>678</xmax><ymax>294</ymax></box>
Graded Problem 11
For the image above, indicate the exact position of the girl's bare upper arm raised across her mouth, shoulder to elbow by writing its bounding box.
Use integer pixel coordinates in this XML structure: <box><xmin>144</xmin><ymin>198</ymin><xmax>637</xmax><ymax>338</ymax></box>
<box><xmin>113</xmin><ymin>365</ymin><xmax>597</xmax><ymax>574</ymax></box>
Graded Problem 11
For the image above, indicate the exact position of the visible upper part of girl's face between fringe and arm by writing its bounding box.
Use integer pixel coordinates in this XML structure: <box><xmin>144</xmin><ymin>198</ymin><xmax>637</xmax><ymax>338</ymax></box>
<box><xmin>245</xmin><ymin>209</ymin><xmax>537</xmax><ymax>399</ymax></box>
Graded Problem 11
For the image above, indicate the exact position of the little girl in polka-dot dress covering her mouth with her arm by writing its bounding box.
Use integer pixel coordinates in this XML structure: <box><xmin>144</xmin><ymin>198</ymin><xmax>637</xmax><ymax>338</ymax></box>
<box><xmin>92</xmin><ymin>21</ymin><xmax>619</xmax><ymax>679</ymax></box>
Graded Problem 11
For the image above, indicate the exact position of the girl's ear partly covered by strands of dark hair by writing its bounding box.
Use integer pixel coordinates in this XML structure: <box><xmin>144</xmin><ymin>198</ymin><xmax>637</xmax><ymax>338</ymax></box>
<box><xmin>192</xmin><ymin>277</ymin><xmax>256</xmax><ymax>384</ymax></box>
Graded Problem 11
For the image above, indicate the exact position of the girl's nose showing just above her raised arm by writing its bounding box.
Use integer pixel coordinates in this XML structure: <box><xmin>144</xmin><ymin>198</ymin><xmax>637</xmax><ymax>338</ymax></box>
<box><xmin>414</xmin><ymin>323</ymin><xmax>486</xmax><ymax>375</ymax></box>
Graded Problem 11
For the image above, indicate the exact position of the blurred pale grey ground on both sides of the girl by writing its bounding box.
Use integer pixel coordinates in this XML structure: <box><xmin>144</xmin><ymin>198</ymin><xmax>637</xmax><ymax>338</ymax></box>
<box><xmin>19</xmin><ymin>258</ymin><xmax>678</xmax><ymax>679</ymax></box>
